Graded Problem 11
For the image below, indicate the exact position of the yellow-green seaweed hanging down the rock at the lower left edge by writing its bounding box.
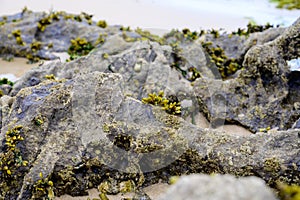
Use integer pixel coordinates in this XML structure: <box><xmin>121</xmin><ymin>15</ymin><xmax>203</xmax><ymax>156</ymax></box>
<box><xmin>0</xmin><ymin>125</ymin><xmax>28</xmax><ymax>199</ymax></box>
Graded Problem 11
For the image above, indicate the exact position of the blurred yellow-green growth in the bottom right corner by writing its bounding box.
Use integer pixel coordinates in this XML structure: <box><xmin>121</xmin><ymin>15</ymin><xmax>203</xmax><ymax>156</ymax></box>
<box><xmin>277</xmin><ymin>183</ymin><xmax>300</xmax><ymax>200</ymax></box>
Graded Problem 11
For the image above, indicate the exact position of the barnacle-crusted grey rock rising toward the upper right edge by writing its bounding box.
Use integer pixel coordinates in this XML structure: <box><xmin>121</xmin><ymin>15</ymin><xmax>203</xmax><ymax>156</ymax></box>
<box><xmin>194</xmin><ymin>19</ymin><xmax>300</xmax><ymax>132</ymax></box>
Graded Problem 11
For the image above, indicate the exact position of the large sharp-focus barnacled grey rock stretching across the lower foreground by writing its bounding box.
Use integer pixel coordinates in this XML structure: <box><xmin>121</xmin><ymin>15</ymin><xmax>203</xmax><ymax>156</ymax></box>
<box><xmin>0</xmin><ymin>72</ymin><xmax>300</xmax><ymax>199</ymax></box>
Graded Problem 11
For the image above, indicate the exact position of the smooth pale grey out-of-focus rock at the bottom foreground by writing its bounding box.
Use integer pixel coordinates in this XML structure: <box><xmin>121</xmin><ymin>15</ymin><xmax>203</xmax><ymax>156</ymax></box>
<box><xmin>159</xmin><ymin>174</ymin><xmax>277</xmax><ymax>200</ymax></box>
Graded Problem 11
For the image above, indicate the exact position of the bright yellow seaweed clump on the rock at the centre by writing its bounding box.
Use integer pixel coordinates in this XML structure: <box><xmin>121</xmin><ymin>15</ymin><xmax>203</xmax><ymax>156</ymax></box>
<box><xmin>142</xmin><ymin>91</ymin><xmax>181</xmax><ymax>115</ymax></box>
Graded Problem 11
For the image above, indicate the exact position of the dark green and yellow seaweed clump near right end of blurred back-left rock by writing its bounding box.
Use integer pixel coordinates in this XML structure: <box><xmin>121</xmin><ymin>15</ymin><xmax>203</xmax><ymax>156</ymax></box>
<box><xmin>68</xmin><ymin>38</ymin><xmax>94</xmax><ymax>61</ymax></box>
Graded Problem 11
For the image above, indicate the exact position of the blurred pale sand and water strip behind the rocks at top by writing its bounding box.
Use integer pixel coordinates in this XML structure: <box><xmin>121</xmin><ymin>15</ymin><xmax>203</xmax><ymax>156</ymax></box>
<box><xmin>0</xmin><ymin>0</ymin><xmax>300</xmax><ymax>31</ymax></box>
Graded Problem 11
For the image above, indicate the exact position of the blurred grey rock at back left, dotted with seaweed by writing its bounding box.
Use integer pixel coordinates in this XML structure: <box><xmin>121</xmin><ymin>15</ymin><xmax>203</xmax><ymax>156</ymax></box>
<box><xmin>0</xmin><ymin>9</ymin><xmax>120</xmax><ymax>60</ymax></box>
